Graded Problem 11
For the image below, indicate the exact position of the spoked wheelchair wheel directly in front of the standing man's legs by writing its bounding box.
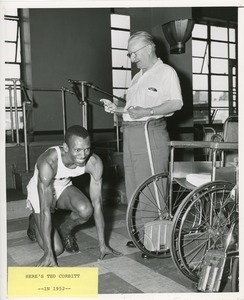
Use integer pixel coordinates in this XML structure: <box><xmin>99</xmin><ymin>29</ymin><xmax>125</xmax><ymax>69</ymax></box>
<box><xmin>126</xmin><ymin>173</ymin><xmax>172</xmax><ymax>258</ymax></box>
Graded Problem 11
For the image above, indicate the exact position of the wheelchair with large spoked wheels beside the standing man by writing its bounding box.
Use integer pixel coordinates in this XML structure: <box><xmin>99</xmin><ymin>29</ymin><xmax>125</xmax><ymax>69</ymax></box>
<box><xmin>126</xmin><ymin>120</ymin><xmax>238</xmax><ymax>290</ymax></box>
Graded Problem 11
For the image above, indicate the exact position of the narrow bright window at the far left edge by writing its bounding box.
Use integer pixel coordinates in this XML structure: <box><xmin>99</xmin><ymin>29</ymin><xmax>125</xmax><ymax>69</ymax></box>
<box><xmin>4</xmin><ymin>9</ymin><xmax>23</xmax><ymax>141</ymax></box>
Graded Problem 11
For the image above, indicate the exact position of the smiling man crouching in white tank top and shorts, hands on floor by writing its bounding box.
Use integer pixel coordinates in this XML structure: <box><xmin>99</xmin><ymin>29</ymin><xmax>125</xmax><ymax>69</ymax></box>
<box><xmin>27</xmin><ymin>125</ymin><xmax>120</xmax><ymax>266</ymax></box>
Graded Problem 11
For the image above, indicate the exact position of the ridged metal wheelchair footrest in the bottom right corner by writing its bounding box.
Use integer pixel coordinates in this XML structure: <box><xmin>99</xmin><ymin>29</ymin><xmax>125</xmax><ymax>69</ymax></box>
<box><xmin>198</xmin><ymin>249</ymin><xmax>226</xmax><ymax>292</ymax></box>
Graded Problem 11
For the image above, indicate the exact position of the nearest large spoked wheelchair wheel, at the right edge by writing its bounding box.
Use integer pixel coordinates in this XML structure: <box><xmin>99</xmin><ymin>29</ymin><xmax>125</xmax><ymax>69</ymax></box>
<box><xmin>171</xmin><ymin>181</ymin><xmax>238</xmax><ymax>282</ymax></box>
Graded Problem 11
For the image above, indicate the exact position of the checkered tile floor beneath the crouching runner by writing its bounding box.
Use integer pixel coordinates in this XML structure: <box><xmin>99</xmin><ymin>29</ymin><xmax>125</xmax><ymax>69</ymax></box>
<box><xmin>7</xmin><ymin>205</ymin><xmax>234</xmax><ymax>294</ymax></box>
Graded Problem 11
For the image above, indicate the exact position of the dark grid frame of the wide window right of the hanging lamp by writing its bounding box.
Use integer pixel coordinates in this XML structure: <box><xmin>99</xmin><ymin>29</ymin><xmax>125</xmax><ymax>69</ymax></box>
<box><xmin>192</xmin><ymin>20</ymin><xmax>238</xmax><ymax>126</ymax></box>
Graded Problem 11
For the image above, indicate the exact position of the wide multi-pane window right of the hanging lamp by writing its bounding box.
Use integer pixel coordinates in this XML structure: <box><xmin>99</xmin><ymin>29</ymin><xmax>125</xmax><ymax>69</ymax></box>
<box><xmin>192</xmin><ymin>23</ymin><xmax>238</xmax><ymax>124</ymax></box>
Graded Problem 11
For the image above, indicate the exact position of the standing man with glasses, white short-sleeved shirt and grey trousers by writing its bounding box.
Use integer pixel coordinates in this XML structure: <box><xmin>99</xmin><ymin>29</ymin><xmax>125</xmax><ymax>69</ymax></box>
<box><xmin>101</xmin><ymin>31</ymin><xmax>183</xmax><ymax>255</ymax></box>
